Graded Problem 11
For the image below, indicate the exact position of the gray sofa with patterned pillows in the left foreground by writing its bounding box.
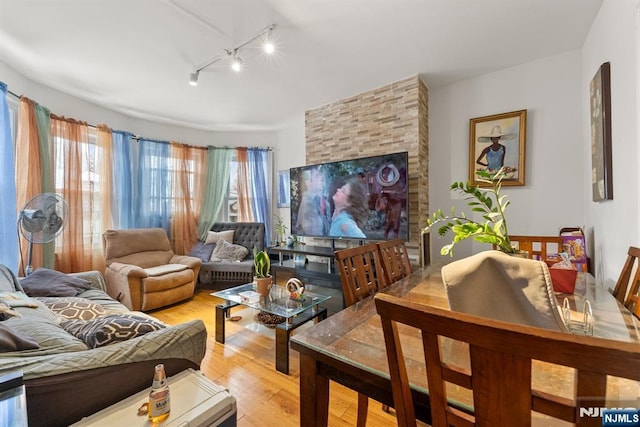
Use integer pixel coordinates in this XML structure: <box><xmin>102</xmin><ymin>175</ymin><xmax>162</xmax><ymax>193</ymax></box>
<box><xmin>0</xmin><ymin>265</ymin><xmax>207</xmax><ymax>426</ymax></box>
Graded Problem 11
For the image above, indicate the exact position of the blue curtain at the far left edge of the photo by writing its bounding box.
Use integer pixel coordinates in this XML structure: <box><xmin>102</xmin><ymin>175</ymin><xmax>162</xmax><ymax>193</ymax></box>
<box><xmin>0</xmin><ymin>82</ymin><xmax>18</xmax><ymax>274</ymax></box>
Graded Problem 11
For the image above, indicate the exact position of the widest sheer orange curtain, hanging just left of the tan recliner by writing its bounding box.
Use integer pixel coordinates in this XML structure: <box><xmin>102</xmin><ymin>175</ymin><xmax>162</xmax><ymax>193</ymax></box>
<box><xmin>51</xmin><ymin>115</ymin><xmax>111</xmax><ymax>273</ymax></box>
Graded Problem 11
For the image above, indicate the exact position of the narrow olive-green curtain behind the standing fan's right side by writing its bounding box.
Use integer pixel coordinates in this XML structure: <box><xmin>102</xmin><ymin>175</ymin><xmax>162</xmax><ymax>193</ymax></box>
<box><xmin>35</xmin><ymin>103</ymin><xmax>56</xmax><ymax>269</ymax></box>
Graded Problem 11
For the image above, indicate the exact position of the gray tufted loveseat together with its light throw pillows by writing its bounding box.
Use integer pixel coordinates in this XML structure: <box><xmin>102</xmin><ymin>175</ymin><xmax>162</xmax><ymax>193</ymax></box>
<box><xmin>190</xmin><ymin>222</ymin><xmax>265</xmax><ymax>290</ymax></box>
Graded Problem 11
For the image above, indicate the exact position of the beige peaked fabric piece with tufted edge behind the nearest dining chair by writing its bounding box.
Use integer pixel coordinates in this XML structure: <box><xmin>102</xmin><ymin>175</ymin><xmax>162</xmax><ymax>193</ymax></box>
<box><xmin>442</xmin><ymin>250</ymin><xmax>567</xmax><ymax>331</ymax></box>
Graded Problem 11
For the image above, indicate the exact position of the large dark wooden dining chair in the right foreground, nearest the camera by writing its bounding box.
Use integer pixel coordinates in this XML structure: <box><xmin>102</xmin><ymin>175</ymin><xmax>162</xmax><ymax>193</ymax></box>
<box><xmin>374</xmin><ymin>294</ymin><xmax>640</xmax><ymax>427</ymax></box>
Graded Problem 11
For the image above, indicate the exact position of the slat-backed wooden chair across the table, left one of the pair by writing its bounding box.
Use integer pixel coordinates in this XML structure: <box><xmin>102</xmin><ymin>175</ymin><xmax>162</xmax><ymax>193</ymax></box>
<box><xmin>334</xmin><ymin>243</ymin><xmax>388</xmax><ymax>427</ymax></box>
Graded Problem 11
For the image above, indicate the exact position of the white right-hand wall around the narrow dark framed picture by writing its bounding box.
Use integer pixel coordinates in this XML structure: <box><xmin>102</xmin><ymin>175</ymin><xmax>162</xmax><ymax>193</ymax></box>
<box><xmin>579</xmin><ymin>0</ymin><xmax>640</xmax><ymax>284</ymax></box>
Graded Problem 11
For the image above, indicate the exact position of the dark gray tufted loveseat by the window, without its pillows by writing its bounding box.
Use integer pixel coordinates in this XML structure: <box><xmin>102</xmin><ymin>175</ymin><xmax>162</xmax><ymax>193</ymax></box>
<box><xmin>200</xmin><ymin>222</ymin><xmax>265</xmax><ymax>289</ymax></box>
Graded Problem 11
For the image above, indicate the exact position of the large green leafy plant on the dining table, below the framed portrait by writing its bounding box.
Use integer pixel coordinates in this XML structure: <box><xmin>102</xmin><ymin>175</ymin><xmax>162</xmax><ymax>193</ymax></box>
<box><xmin>422</xmin><ymin>169</ymin><xmax>517</xmax><ymax>256</ymax></box>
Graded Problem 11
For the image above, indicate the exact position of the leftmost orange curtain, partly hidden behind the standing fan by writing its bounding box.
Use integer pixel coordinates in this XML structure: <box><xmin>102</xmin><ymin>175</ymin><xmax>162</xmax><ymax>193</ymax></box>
<box><xmin>16</xmin><ymin>96</ymin><xmax>42</xmax><ymax>276</ymax></box>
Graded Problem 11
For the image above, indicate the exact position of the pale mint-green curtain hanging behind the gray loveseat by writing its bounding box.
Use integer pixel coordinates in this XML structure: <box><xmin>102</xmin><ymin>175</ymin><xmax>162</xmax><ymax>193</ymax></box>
<box><xmin>198</xmin><ymin>147</ymin><xmax>234</xmax><ymax>239</ymax></box>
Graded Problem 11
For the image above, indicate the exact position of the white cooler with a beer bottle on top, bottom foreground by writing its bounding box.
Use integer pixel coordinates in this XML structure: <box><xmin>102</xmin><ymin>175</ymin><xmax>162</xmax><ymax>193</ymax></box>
<box><xmin>73</xmin><ymin>369</ymin><xmax>237</xmax><ymax>427</ymax></box>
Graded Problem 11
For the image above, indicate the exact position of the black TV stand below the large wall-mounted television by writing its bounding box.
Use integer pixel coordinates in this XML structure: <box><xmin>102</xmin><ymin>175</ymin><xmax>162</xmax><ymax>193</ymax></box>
<box><xmin>268</xmin><ymin>244</ymin><xmax>342</xmax><ymax>289</ymax></box>
